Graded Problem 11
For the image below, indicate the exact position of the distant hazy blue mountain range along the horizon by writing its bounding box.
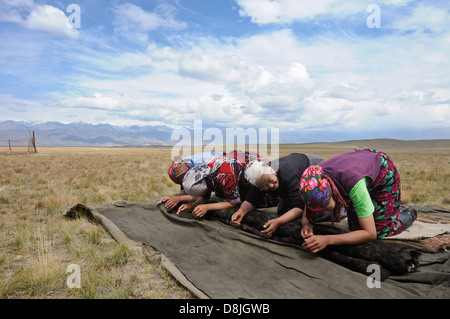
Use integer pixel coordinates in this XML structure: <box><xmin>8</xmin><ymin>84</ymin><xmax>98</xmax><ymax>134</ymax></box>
<box><xmin>0</xmin><ymin>120</ymin><xmax>450</xmax><ymax>148</ymax></box>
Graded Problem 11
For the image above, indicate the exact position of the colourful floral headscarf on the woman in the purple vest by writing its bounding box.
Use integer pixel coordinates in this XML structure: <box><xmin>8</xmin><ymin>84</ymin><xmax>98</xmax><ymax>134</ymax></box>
<box><xmin>300</xmin><ymin>166</ymin><xmax>333</xmax><ymax>211</ymax></box>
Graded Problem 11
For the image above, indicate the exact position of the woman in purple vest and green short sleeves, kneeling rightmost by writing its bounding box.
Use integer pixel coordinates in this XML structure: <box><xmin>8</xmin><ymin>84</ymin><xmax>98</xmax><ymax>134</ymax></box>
<box><xmin>300</xmin><ymin>149</ymin><xmax>417</xmax><ymax>253</ymax></box>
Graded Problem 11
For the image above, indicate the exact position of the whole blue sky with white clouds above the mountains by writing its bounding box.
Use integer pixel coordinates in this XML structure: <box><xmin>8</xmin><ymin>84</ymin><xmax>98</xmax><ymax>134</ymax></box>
<box><xmin>0</xmin><ymin>0</ymin><xmax>450</xmax><ymax>142</ymax></box>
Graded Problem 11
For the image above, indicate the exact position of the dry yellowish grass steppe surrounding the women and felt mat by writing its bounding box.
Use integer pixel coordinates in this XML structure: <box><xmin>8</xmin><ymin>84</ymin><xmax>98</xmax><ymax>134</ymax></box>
<box><xmin>0</xmin><ymin>140</ymin><xmax>450</xmax><ymax>299</ymax></box>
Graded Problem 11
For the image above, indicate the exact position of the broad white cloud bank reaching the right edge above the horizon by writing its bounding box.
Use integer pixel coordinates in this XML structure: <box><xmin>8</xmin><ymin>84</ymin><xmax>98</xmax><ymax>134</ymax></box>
<box><xmin>51</xmin><ymin>21</ymin><xmax>450</xmax><ymax>132</ymax></box>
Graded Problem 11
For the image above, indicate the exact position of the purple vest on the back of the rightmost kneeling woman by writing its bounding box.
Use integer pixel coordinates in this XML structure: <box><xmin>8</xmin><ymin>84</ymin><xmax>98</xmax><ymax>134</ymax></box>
<box><xmin>318</xmin><ymin>151</ymin><xmax>381</xmax><ymax>200</ymax></box>
